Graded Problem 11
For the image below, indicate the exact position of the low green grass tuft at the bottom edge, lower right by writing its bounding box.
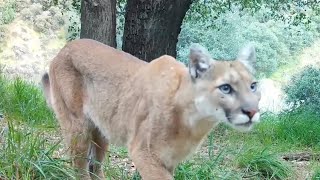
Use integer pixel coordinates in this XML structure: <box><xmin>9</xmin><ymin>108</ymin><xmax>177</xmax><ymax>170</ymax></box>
<box><xmin>237</xmin><ymin>148</ymin><xmax>292</xmax><ymax>179</ymax></box>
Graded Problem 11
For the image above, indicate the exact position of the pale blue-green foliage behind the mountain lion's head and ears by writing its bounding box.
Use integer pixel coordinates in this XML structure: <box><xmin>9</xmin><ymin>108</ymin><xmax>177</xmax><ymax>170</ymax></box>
<box><xmin>177</xmin><ymin>6</ymin><xmax>320</xmax><ymax>76</ymax></box>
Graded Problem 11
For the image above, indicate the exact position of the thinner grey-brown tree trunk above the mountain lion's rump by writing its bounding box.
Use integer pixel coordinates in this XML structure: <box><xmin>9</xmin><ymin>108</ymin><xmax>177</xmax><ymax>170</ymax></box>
<box><xmin>80</xmin><ymin>0</ymin><xmax>116</xmax><ymax>47</ymax></box>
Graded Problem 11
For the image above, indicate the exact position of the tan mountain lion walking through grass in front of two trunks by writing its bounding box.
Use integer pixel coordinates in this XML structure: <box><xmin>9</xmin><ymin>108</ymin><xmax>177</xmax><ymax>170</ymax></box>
<box><xmin>43</xmin><ymin>39</ymin><xmax>260</xmax><ymax>180</ymax></box>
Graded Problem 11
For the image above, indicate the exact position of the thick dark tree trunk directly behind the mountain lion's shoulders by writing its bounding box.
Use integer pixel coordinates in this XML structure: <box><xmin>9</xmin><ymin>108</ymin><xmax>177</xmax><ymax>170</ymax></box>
<box><xmin>122</xmin><ymin>0</ymin><xmax>192</xmax><ymax>62</ymax></box>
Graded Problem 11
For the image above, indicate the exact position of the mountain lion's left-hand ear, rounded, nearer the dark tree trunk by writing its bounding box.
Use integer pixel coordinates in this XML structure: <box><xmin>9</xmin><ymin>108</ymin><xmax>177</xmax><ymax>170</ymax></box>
<box><xmin>189</xmin><ymin>43</ymin><xmax>212</xmax><ymax>79</ymax></box>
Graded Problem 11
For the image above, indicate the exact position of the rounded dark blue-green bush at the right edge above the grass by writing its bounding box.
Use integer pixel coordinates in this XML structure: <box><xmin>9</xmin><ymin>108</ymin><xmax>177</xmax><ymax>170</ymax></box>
<box><xmin>284</xmin><ymin>66</ymin><xmax>320</xmax><ymax>113</ymax></box>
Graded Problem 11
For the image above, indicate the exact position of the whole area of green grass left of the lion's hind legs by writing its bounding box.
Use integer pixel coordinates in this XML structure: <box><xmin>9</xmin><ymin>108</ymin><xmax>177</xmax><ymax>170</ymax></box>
<box><xmin>0</xmin><ymin>73</ymin><xmax>74</xmax><ymax>179</ymax></box>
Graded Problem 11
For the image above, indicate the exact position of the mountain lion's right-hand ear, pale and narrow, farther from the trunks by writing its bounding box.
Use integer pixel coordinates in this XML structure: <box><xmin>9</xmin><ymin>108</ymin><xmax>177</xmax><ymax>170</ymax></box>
<box><xmin>237</xmin><ymin>44</ymin><xmax>256</xmax><ymax>74</ymax></box>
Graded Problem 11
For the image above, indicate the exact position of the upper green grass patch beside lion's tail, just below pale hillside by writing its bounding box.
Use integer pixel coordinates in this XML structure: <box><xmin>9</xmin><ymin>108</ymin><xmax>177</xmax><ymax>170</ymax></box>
<box><xmin>0</xmin><ymin>73</ymin><xmax>56</xmax><ymax>127</ymax></box>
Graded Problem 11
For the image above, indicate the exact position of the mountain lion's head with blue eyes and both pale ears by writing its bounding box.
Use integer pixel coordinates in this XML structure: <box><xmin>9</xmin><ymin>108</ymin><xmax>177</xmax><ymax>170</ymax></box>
<box><xmin>189</xmin><ymin>44</ymin><xmax>261</xmax><ymax>131</ymax></box>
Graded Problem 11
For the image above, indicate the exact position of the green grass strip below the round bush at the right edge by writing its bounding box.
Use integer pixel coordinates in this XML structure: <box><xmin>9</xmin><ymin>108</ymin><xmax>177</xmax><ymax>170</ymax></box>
<box><xmin>242</xmin><ymin>110</ymin><xmax>320</xmax><ymax>151</ymax></box>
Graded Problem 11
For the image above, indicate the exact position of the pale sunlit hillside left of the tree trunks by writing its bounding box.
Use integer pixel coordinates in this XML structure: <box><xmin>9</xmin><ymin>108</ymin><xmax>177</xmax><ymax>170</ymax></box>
<box><xmin>0</xmin><ymin>0</ymin><xmax>75</xmax><ymax>82</ymax></box>
